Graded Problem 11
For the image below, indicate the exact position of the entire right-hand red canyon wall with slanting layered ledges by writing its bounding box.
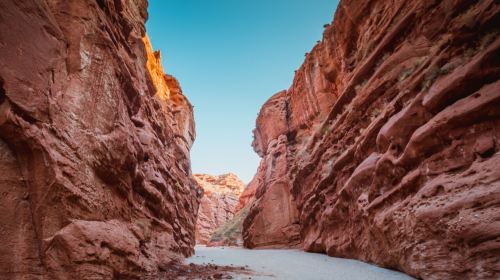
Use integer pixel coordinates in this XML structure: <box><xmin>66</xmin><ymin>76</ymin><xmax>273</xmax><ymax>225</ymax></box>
<box><xmin>243</xmin><ymin>0</ymin><xmax>500</xmax><ymax>279</ymax></box>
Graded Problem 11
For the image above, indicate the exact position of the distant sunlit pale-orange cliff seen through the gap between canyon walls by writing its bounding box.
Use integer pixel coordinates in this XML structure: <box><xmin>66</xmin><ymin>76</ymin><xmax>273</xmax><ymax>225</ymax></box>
<box><xmin>194</xmin><ymin>173</ymin><xmax>245</xmax><ymax>244</ymax></box>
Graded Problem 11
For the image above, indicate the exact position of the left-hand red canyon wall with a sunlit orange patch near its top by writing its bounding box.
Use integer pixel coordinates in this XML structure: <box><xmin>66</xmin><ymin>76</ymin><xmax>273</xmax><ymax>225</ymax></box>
<box><xmin>0</xmin><ymin>0</ymin><xmax>201</xmax><ymax>279</ymax></box>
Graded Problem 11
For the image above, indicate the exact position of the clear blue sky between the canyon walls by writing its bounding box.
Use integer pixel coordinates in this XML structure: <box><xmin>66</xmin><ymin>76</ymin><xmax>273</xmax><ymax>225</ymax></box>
<box><xmin>146</xmin><ymin>0</ymin><xmax>338</xmax><ymax>183</ymax></box>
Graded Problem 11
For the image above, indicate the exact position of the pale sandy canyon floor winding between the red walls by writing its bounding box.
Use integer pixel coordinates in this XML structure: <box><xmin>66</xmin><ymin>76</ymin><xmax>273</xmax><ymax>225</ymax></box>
<box><xmin>187</xmin><ymin>246</ymin><xmax>414</xmax><ymax>280</ymax></box>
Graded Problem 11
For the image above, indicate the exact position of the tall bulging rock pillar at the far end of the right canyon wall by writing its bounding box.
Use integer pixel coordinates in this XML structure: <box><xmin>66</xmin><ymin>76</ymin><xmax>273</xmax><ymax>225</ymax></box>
<box><xmin>244</xmin><ymin>91</ymin><xmax>300</xmax><ymax>248</ymax></box>
